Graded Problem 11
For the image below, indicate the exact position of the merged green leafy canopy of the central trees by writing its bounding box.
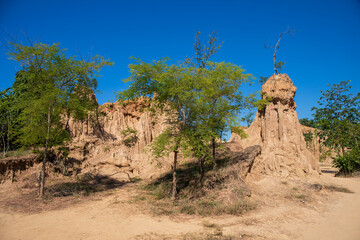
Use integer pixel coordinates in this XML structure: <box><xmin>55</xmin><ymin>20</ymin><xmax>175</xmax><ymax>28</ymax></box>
<box><xmin>118</xmin><ymin>60</ymin><xmax>251</xmax><ymax>158</ymax></box>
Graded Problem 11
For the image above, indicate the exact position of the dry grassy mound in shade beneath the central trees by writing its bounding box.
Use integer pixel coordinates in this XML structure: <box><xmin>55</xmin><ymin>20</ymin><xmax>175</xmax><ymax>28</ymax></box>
<box><xmin>130</xmin><ymin>155</ymin><xmax>257</xmax><ymax>216</ymax></box>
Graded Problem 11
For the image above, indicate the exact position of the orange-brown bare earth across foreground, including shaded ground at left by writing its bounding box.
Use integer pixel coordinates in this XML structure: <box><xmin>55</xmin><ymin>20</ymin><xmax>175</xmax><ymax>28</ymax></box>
<box><xmin>0</xmin><ymin>170</ymin><xmax>360</xmax><ymax>240</ymax></box>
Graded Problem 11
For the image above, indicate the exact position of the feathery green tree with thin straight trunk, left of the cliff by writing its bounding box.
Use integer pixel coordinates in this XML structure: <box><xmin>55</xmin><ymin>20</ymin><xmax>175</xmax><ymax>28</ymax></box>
<box><xmin>9</xmin><ymin>40</ymin><xmax>111</xmax><ymax>196</ymax></box>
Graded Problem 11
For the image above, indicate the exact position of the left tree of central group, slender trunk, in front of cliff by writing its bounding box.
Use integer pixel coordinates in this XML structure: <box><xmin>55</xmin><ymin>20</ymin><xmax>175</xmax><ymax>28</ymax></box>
<box><xmin>118</xmin><ymin>59</ymin><xmax>196</xmax><ymax>199</ymax></box>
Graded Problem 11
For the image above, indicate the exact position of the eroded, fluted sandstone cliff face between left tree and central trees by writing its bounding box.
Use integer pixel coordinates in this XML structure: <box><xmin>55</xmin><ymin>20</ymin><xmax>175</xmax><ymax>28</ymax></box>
<box><xmin>68</xmin><ymin>99</ymin><xmax>169</xmax><ymax>178</ymax></box>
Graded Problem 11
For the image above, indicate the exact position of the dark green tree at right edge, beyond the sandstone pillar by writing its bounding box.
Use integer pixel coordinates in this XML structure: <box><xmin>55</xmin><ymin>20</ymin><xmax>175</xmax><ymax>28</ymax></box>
<box><xmin>313</xmin><ymin>80</ymin><xmax>360</xmax><ymax>173</ymax></box>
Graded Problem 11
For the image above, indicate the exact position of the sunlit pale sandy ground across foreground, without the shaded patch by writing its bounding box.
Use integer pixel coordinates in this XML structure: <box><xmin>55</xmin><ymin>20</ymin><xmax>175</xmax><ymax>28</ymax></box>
<box><xmin>0</xmin><ymin>174</ymin><xmax>360</xmax><ymax>240</ymax></box>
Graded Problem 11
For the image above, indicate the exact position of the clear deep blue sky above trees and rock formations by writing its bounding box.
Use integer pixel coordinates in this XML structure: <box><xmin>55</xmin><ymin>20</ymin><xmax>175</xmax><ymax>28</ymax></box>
<box><xmin>0</xmin><ymin>0</ymin><xmax>360</xmax><ymax>122</ymax></box>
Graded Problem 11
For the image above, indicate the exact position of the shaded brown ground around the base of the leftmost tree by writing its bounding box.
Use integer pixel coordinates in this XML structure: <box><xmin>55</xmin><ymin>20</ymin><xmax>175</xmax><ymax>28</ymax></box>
<box><xmin>0</xmin><ymin>173</ymin><xmax>130</xmax><ymax>213</ymax></box>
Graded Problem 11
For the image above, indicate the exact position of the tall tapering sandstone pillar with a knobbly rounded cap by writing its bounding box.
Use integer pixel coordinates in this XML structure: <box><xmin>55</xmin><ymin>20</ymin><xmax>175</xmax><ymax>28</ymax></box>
<box><xmin>230</xmin><ymin>74</ymin><xmax>319</xmax><ymax>177</ymax></box>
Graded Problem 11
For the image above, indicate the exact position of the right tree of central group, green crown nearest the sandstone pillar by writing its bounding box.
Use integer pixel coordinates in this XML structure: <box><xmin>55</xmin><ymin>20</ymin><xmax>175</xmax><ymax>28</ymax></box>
<box><xmin>190</xmin><ymin>62</ymin><xmax>252</xmax><ymax>182</ymax></box>
